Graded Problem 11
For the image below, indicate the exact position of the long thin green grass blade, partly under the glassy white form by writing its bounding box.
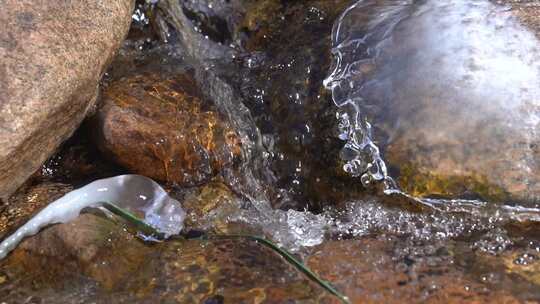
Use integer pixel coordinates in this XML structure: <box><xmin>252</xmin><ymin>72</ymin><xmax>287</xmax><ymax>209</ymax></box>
<box><xmin>103</xmin><ymin>202</ymin><xmax>350</xmax><ymax>304</ymax></box>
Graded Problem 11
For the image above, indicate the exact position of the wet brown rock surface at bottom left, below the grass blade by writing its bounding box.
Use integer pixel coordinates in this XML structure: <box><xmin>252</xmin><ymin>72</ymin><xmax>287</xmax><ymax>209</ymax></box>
<box><xmin>0</xmin><ymin>214</ymin><xmax>332</xmax><ymax>303</ymax></box>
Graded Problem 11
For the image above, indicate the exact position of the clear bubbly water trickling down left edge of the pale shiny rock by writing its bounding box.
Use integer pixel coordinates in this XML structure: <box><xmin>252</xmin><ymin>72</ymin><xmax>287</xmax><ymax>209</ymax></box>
<box><xmin>324</xmin><ymin>1</ymin><xmax>412</xmax><ymax>189</ymax></box>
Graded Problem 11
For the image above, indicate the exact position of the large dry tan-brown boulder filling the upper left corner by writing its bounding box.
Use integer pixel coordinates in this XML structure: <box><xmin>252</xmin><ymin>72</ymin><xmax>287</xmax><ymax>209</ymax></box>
<box><xmin>0</xmin><ymin>0</ymin><xmax>134</xmax><ymax>198</ymax></box>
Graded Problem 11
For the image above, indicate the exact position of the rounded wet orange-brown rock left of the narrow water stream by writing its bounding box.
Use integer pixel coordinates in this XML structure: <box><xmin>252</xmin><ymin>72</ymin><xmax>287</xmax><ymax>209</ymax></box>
<box><xmin>96</xmin><ymin>73</ymin><xmax>241</xmax><ymax>185</ymax></box>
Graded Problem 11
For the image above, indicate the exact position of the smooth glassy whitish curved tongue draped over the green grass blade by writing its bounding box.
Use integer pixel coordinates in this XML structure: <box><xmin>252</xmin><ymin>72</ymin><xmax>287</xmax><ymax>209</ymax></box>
<box><xmin>0</xmin><ymin>175</ymin><xmax>186</xmax><ymax>259</ymax></box>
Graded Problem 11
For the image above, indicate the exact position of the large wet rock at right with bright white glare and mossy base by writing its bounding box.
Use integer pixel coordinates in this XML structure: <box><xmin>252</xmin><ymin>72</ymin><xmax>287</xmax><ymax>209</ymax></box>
<box><xmin>327</xmin><ymin>0</ymin><xmax>540</xmax><ymax>202</ymax></box>
